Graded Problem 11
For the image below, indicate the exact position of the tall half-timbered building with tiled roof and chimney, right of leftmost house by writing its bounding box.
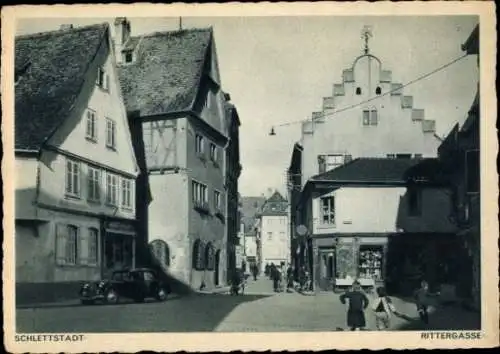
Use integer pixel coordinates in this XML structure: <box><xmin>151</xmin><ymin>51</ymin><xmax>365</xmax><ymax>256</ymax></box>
<box><xmin>114</xmin><ymin>18</ymin><xmax>241</xmax><ymax>289</ymax></box>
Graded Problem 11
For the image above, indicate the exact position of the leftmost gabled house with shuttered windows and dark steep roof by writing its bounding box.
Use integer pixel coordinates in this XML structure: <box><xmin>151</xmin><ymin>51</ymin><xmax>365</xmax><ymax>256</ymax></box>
<box><xmin>15</xmin><ymin>24</ymin><xmax>139</xmax><ymax>303</ymax></box>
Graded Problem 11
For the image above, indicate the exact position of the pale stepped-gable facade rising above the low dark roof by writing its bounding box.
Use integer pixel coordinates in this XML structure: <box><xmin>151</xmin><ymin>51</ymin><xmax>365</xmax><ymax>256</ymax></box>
<box><xmin>300</xmin><ymin>30</ymin><xmax>440</xmax><ymax>186</ymax></box>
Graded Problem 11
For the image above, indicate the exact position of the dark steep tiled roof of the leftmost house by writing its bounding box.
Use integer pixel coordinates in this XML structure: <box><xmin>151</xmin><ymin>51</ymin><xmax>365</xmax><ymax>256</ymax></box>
<box><xmin>14</xmin><ymin>24</ymin><xmax>108</xmax><ymax>150</ymax></box>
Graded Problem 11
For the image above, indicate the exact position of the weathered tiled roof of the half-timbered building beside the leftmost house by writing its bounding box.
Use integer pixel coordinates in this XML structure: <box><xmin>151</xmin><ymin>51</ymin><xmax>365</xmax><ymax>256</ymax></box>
<box><xmin>119</xmin><ymin>28</ymin><xmax>212</xmax><ymax>117</ymax></box>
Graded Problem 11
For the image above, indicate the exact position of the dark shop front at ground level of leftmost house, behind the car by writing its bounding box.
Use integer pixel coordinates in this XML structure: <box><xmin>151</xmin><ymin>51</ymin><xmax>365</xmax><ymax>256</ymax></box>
<box><xmin>102</xmin><ymin>219</ymin><xmax>137</xmax><ymax>277</ymax></box>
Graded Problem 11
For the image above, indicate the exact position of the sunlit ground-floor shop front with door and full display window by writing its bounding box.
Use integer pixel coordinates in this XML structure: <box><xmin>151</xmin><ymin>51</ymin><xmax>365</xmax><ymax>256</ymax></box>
<box><xmin>313</xmin><ymin>235</ymin><xmax>387</xmax><ymax>291</ymax></box>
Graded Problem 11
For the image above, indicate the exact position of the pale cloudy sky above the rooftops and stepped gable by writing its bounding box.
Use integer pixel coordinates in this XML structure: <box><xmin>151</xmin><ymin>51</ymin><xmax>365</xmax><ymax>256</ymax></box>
<box><xmin>16</xmin><ymin>16</ymin><xmax>479</xmax><ymax>196</ymax></box>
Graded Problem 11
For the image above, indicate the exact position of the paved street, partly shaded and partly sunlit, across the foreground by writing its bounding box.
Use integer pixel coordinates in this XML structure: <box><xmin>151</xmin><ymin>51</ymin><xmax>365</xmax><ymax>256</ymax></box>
<box><xmin>16</xmin><ymin>279</ymin><xmax>478</xmax><ymax>333</ymax></box>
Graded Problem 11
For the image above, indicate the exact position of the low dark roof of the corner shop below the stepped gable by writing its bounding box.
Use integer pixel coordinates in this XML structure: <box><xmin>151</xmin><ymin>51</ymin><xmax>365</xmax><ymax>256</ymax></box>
<box><xmin>310</xmin><ymin>158</ymin><xmax>435</xmax><ymax>184</ymax></box>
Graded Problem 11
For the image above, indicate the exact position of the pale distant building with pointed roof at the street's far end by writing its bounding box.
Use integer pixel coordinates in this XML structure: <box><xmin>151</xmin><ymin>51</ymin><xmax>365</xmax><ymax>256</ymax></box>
<box><xmin>257</xmin><ymin>191</ymin><xmax>290</xmax><ymax>272</ymax></box>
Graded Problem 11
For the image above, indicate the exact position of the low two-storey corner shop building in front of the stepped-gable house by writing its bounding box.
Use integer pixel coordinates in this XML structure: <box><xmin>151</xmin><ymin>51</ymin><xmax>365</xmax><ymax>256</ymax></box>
<box><xmin>299</xmin><ymin>158</ymin><xmax>458</xmax><ymax>293</ymax></box>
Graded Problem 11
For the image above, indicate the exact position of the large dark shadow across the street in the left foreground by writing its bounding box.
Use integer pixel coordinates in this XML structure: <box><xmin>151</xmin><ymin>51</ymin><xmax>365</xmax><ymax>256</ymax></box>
<box><xmin>16</xmin><ymin>294</ymin><xmax>268</xmax><ymax>333</ymax></box>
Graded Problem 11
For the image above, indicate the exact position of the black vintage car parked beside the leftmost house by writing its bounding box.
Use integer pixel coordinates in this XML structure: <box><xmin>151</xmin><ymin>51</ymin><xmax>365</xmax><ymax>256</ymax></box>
<box><xmin>80</xmin><ymin>268</ymin><xmax>170</xmax><ymax>304</ymax></box>
